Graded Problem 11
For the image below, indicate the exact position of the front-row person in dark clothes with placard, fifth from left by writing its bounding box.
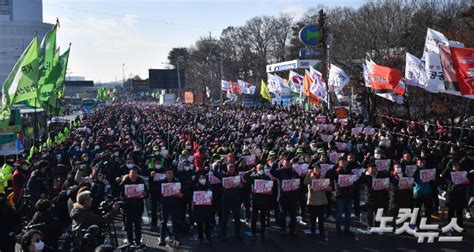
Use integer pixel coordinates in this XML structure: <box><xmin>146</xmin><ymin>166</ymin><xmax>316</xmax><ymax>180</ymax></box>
<box><xmin>243</xmin><ymin>164</ymin><xmax>272</xmax><ymax>240</ymax></box>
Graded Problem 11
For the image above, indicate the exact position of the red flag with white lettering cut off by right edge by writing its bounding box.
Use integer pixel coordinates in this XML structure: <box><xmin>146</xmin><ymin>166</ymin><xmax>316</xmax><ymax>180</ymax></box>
<box><xmin>451</xmin><ymin>47</ymin><xmax>474</xmax><ymax>95</ymax></box>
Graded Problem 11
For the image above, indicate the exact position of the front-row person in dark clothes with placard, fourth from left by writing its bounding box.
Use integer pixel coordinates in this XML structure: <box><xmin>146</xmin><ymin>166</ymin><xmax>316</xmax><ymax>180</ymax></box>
<box><xmin>213</xmin><ymin>163</ymin><xmax>242</xmax><ymax>241</ymax></box>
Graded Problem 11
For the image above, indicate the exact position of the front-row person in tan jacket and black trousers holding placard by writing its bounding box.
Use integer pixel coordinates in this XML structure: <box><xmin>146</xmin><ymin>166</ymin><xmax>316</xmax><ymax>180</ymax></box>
<box><xmin>304</xmin><ymin>165</ymin><xmax>330</xmax><ymax>240</ymax></box>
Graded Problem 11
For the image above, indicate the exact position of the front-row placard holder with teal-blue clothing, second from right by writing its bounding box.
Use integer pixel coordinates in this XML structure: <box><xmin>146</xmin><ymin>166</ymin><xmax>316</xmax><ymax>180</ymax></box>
<box><xmin>413</xmin><ymin>157</ymin><xmax>433</xmax><ymax>224</ymax></box>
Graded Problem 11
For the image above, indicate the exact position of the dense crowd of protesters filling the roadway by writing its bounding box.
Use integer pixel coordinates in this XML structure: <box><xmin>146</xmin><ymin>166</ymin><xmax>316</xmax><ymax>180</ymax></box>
<box><xmin>0</xmin><ymin>102</ymin><xmax>474</xmax><ymax>251</ymax></box>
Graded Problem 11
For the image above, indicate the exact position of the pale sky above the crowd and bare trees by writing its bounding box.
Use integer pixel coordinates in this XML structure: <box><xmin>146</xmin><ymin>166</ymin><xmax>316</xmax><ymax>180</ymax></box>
<box><xmin>43</xmin><ymin>0</ymin><xmax>365</xmax><ymax>82</ymax></box>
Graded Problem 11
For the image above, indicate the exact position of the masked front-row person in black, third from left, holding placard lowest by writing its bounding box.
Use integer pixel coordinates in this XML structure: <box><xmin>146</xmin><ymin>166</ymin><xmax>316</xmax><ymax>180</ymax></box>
<box><xmin>193</xmin><ymin>172</ymin><xmax>213</xmax><ymax>244</ymax></box>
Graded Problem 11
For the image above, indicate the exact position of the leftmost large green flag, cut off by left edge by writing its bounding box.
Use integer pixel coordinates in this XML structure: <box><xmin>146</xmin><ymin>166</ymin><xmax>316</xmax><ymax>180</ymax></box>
<box><xmin>0</xmin><ymin>36</ymin><xmax>39</xmax><ymax>125</ymax></box>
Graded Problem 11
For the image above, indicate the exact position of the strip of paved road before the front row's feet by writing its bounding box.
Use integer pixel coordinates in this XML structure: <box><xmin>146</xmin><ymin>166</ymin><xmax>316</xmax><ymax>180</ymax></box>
<box><xmin>111</xmin><ymin>199</ymin><xmax>474</xmax><ymax>252</ymax></box>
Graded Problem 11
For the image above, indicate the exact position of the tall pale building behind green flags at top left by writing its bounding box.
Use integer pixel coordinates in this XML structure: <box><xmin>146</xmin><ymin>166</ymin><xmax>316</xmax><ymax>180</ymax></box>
<box><xmin>0</xmin><ymin>0</ymin><xmax>52</xmax><ymax>85</ymax></box>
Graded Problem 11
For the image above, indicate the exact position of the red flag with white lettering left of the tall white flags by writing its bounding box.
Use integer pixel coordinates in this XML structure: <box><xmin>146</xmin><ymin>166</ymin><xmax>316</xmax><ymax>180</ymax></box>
<box><xmin>369</xmin><ymin>64</ymin><xmax>402</xmax><ymax>91</ymax></box>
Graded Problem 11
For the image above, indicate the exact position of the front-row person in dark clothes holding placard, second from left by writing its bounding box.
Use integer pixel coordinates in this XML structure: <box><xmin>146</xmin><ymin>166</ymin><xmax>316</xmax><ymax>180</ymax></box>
<box><xmin>159</xmin><ymin>168</ymin><xmax>183</xmax><ymax>246</ymax></box>
